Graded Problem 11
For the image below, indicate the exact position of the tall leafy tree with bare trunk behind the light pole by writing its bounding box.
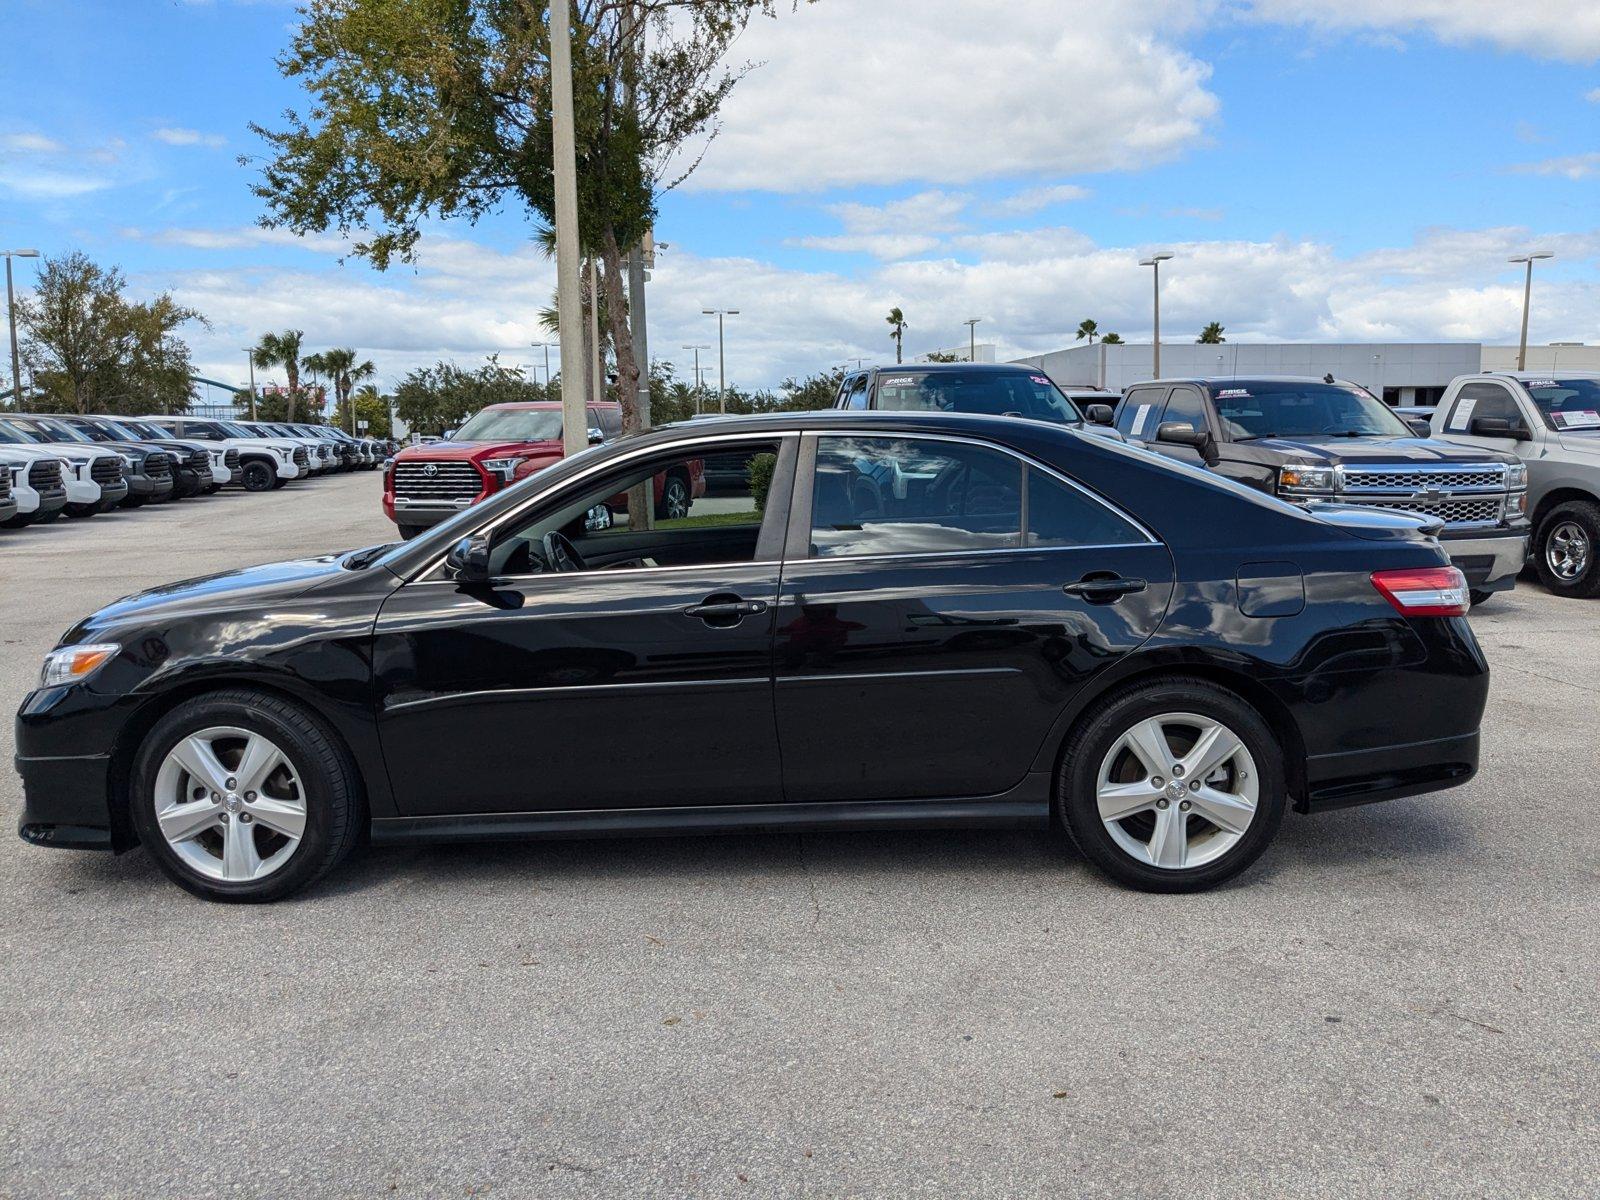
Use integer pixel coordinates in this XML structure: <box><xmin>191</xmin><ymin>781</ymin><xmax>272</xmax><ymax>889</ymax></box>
<box><xmin>251</xmin><ymin>0</ymin><xmax>800</xmax><ymax>441</ymax></box>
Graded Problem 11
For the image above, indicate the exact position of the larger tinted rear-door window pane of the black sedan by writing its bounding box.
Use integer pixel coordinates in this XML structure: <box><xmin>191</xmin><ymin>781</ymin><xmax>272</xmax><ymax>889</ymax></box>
<box><xmin>811</xmin><ymin>437</ymin><xmax>1022</xmax><ymax>558</ymax></box>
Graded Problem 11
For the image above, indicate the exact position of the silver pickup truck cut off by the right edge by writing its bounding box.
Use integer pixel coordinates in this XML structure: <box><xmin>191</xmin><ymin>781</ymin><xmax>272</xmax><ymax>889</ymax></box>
<box><xmin>1432</xmin><ymin>371</ymin><xmax>1600</xmax><ymax>597</ymax></box>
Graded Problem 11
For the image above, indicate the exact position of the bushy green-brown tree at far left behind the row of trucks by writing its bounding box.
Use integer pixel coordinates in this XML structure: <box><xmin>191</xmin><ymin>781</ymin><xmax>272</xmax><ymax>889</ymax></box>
<box><xmin>16</xmin><ymin>251</ymin><xmax>205</xmax><ymax>413</ymax></box>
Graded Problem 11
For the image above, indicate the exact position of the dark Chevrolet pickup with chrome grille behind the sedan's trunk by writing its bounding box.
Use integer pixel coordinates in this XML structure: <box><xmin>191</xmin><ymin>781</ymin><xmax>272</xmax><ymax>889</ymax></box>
<box><xmin>1090</xmin><ymin>376</ymin><xmax>1528</xmax><ymax>603</ymax></box>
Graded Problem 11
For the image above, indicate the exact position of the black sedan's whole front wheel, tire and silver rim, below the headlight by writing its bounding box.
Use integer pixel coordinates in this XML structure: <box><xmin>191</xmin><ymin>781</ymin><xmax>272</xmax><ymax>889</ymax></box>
<box><xmin>130</xmin><ymin>690</ymin><xmax>362</xmax><ymax>902</ymax></box>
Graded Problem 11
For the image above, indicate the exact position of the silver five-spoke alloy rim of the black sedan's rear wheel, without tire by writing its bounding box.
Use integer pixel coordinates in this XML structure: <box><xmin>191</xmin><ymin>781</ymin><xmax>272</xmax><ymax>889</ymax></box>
<box><xmin>1094</xmin><ymin>712</ymin><xmax>1261</xmax><ymax>870</ymax></box>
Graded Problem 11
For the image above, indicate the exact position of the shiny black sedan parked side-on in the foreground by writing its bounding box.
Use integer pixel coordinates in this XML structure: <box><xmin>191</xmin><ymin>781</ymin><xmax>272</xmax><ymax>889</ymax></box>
<box><xmin>16</xmin><ymin>413</ymin><xmax>1488</xmax><ymax>901</ymax></box>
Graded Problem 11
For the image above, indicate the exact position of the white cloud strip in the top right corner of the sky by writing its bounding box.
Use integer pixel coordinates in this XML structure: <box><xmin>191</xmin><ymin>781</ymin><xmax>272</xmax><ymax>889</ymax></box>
<box><xmin>1248</xmin><ymin>0</ymin><xmax>1600</xmax><ymax>62</ymax></box>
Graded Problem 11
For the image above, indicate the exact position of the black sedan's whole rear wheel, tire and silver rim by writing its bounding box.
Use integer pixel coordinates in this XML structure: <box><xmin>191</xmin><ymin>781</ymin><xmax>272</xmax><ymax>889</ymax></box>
<box><xmin>1058</xmin><ymin>678</ymin><xmax>1286</xmax><ymax>891</ymax></box>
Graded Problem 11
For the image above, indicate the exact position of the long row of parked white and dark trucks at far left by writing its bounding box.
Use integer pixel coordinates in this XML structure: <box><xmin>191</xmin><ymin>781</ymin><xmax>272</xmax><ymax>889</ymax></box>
<box><xmin>0</xmin><ymin>411</ymin><xmax>390</xmax><ymax>530</ymax></box>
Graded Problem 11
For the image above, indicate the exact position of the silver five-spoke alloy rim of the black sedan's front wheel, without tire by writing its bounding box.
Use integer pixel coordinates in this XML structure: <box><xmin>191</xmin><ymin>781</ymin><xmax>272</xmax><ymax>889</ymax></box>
<box><xmin>155</xmin><ymin>725</ymin><xmax>306</xmax><ymax>883</ymax></box>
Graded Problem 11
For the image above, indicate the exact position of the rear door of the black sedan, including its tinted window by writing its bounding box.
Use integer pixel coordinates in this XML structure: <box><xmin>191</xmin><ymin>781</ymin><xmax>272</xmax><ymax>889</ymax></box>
<box><xmin>774</xmin><ymin>434</ymin><xmax>1173</xmax><ymax>802</ymax></box>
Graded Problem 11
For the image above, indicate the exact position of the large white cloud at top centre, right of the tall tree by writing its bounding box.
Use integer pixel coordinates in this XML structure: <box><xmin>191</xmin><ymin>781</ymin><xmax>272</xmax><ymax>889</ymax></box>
<box><xmin>672</xmin><ymin>0</ymin><xmax>1218</xmax><ymax>192</ymax></box>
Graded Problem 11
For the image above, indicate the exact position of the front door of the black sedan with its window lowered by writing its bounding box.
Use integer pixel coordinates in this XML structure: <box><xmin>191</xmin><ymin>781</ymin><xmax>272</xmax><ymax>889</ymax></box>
<box><xmin>373</xmin><ymin>435</ymin><xmax>798</xmax><ymax>814</ymax></box>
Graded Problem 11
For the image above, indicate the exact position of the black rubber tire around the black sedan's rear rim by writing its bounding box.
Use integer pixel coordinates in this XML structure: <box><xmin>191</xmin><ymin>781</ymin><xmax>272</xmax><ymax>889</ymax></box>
<box><xmin>1056</xmin><ymin>677</ymin><xmax>1288</xmax><ymax>893</ymax></box>
